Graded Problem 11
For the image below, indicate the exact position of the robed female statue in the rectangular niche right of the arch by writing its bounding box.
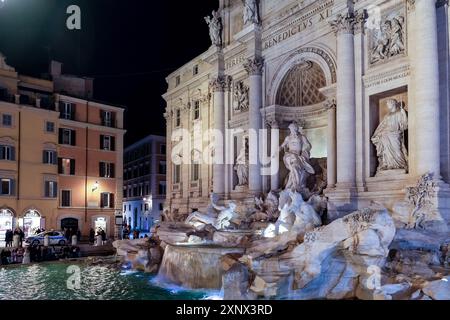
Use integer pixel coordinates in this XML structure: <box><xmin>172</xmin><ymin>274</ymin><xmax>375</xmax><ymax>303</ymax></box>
<box><xmin>372</xmin><ymin>99</ymin><xmax>408</xmax><ymax>172</ymax></box>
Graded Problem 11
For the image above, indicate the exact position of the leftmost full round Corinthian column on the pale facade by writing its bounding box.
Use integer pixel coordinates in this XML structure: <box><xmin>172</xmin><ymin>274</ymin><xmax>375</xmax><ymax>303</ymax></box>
<box><xmin>211</xmin><ymin>76</ymin><xmax>231</xmax><ymax>195</ymax></box>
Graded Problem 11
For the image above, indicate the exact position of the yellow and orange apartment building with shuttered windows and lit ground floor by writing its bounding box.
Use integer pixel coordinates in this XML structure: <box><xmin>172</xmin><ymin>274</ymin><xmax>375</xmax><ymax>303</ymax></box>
<box><xmin>0</xmin><ymin>54</ymin><xmax>125</xmax><ymax>241</ymax></box>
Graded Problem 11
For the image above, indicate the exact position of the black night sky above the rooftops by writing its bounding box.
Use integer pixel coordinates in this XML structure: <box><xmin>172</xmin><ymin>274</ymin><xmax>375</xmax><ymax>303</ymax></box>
<box><xmin>0</xmin><ymin>0</ymin><xmax>218</xmax><ymax>144</ymax></box>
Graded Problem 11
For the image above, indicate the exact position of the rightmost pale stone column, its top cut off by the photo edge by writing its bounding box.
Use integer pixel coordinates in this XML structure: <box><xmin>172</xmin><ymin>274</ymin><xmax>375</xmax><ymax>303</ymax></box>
<box><xmin>413</xmin><ymin>0</ymin><xmax>441</xmax><ymax>179</ymax></box>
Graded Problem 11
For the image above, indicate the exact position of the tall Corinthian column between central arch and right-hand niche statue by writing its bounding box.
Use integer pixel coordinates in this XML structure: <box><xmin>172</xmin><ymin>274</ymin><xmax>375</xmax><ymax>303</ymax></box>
<box><xmin>331</xmin><ymin>13</ymin><xmax>356</xmax><ymax>188</ymax></box>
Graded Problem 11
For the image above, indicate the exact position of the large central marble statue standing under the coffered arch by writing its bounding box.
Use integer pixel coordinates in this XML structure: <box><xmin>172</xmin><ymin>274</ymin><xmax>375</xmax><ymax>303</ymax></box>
<box><xmin>281</xmin><ymin>123</ymin><xmax>315</xmax><ymax>192</ymax></box>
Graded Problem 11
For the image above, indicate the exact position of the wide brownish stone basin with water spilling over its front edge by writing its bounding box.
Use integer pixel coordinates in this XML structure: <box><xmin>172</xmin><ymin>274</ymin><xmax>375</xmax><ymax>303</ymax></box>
<box><xmin>158</xmin><ymin>244</ymin><xmax>245</xmax><ymax>290</ymax></box>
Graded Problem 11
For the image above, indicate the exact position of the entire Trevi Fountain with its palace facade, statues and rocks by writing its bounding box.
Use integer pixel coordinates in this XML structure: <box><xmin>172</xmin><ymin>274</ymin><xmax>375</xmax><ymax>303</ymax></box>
<box><xmin>114</xmin><ymin>0</ymin><xmax>450</xmax><ymax>300</ymax></box>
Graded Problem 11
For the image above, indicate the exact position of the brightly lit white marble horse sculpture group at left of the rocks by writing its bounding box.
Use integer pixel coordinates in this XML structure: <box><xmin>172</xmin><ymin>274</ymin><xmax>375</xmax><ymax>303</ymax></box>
<box><xmin>185</xmin><ymin>194</ymin><xmax>237</xmax><ymax>230</ymax></box>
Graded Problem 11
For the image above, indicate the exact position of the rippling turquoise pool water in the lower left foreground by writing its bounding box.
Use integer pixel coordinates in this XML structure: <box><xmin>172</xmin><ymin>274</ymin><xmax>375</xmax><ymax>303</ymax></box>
<box><xmin>0</xmin><ymin>263</ymin><xmax>207</xmax><ymax>300</ymax></box>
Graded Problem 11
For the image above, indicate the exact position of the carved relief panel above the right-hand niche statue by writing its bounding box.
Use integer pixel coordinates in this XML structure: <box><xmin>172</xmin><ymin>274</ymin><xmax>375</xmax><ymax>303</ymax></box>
<box><xmin>370</xmin><ymin>16</ymin><xmax>406</xmax><ymax>64</ymax></box>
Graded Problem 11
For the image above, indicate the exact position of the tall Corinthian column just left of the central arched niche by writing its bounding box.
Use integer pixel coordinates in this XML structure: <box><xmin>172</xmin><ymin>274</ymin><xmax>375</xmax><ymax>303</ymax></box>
<box><xmin>244</xmin><ymin>58</ymin><xmax>264</xmax><ymax>194</ymax></box>
